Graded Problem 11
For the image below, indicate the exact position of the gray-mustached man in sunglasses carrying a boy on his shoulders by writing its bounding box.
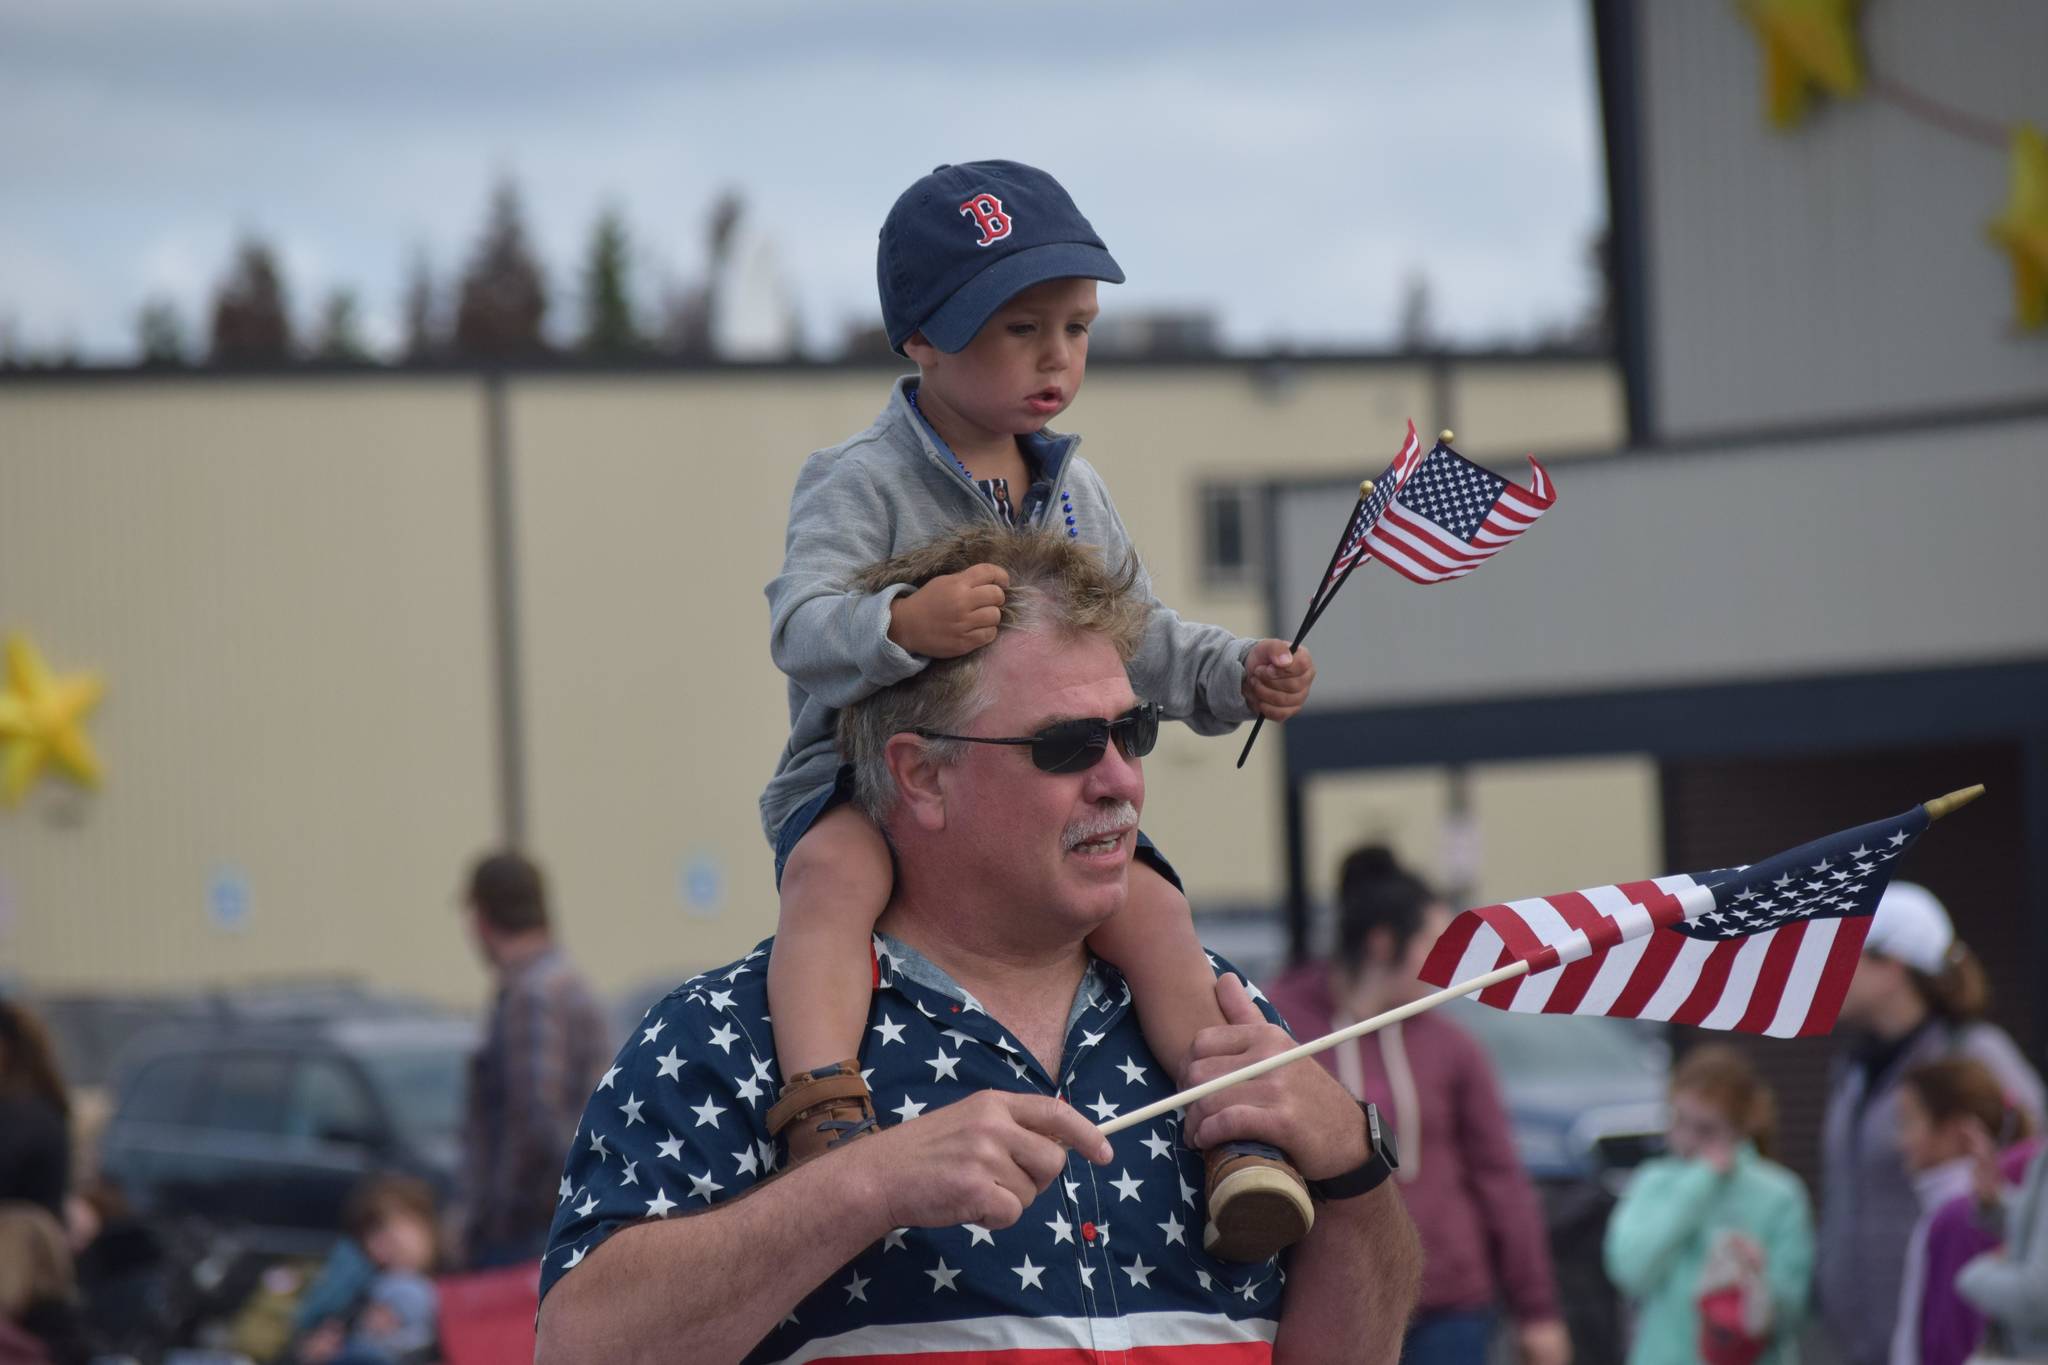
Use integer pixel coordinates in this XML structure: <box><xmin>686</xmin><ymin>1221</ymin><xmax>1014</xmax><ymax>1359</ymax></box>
<box><xmin>539</xmin><ymin>528</ymin><xmax>1419</xmax><ymax>1363</ymax></box>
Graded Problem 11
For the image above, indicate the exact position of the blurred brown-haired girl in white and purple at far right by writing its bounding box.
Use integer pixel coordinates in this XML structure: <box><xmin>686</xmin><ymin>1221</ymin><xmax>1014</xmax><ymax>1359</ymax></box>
<box><xmin>1892</xmin><ymin>1058</ymin><xmax>2023</xmax><ymax>1365</ymax></box>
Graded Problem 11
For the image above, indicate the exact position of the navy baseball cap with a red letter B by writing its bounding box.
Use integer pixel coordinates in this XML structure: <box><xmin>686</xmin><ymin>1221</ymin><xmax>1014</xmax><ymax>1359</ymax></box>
<box><xmin>874</xmin><ymin>162</ymin><xmax>1124</xmax><ymax>354</ymax></box>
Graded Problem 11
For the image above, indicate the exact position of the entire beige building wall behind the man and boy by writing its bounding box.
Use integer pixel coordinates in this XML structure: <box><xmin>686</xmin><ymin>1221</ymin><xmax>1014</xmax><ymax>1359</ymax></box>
<box><xmin>0</xmin><ymin>362</ymin><xmax>1628</xmax><ymax>1003</ymax></box>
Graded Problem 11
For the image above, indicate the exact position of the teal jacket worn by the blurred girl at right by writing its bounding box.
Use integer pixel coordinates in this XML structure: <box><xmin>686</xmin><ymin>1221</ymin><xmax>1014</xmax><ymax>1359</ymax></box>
<box><xmin>1606</xmin><ymin>1142</ymin><xmax>1812</xmax><ymax>1365</ymax></box>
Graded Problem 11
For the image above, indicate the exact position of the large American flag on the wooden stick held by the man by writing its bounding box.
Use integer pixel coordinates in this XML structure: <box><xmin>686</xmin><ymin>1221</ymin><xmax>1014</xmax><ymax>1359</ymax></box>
<box><xmin>1421</xmin><ymin>806</ymin><xmax>1927</xmax><ymax>1038</ymax></box>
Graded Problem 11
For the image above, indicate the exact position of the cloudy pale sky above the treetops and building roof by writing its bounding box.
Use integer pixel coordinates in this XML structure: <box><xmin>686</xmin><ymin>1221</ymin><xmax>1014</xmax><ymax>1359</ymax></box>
<box><xmin>0</xmin><ymin>0</ymin><xmax>1606</xmax><ymax>360</ymax></box>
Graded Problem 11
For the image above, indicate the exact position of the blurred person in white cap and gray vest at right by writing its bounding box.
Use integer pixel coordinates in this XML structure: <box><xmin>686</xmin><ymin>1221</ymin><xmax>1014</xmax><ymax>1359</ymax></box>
<box><xmin>1819</xmin><ymin>882</ymin><xmax>2042</xmax><ymax>1365</ymax></box>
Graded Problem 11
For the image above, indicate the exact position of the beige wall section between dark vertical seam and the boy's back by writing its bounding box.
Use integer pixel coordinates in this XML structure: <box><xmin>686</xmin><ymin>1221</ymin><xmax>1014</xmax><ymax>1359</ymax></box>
<box><xmin>510</xmin><ymin>370</ymin><xmax>887</xmax><ymax>988</ymax></box>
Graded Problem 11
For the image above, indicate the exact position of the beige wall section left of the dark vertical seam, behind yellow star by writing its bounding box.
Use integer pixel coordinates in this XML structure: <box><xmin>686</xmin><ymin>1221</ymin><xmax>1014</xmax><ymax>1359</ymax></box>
<box><xmin>0</xmin><ymin>379</ymin><xmax>496</xmax><ymax>997</ymax></box>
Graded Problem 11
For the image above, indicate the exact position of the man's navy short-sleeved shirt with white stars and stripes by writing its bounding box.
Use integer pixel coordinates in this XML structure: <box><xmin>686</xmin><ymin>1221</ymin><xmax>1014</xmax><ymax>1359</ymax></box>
<box><xmin>541</xmin><ymin>937</ymin><xmax>1284</xmax><ymax>1365</ymax></box>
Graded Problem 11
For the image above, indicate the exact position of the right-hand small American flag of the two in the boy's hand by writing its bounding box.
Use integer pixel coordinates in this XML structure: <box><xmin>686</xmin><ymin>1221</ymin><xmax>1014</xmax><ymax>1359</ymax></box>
<box><xmin>1364</xmin><ymin>442</ymin><xmax>1556</xmax><ymax>583</ymax></box>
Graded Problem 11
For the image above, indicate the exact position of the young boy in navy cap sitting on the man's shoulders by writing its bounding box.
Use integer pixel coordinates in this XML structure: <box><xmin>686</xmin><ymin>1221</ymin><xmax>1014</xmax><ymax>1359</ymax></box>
<box><xmin>762</xmin><ymin>162</ymin><xmax>1315</xmax><ymax>1261</ymax></box>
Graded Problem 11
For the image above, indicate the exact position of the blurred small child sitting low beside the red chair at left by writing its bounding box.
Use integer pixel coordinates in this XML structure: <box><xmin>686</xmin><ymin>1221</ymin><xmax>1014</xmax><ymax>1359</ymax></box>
<box><xmin>295</xmin><ymin>1175</ymin><xmax>440</xmax><ymax>1365</ymax></box>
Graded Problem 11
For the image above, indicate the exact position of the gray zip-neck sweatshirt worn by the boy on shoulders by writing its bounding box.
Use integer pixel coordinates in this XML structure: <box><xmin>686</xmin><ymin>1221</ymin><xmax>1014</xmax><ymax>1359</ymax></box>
<box><xmin>762</xmin><ymin>377</ymin><xmax>1253</xmax><ymax>843</ymax></box>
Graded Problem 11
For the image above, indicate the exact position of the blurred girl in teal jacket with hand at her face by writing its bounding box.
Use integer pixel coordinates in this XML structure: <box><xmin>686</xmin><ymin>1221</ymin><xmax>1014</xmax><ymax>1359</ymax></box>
<box><xmin>1606</xmin><ymin>1044</ymin><xmax>1812</xmax><ymax>1365</ymax></box>
